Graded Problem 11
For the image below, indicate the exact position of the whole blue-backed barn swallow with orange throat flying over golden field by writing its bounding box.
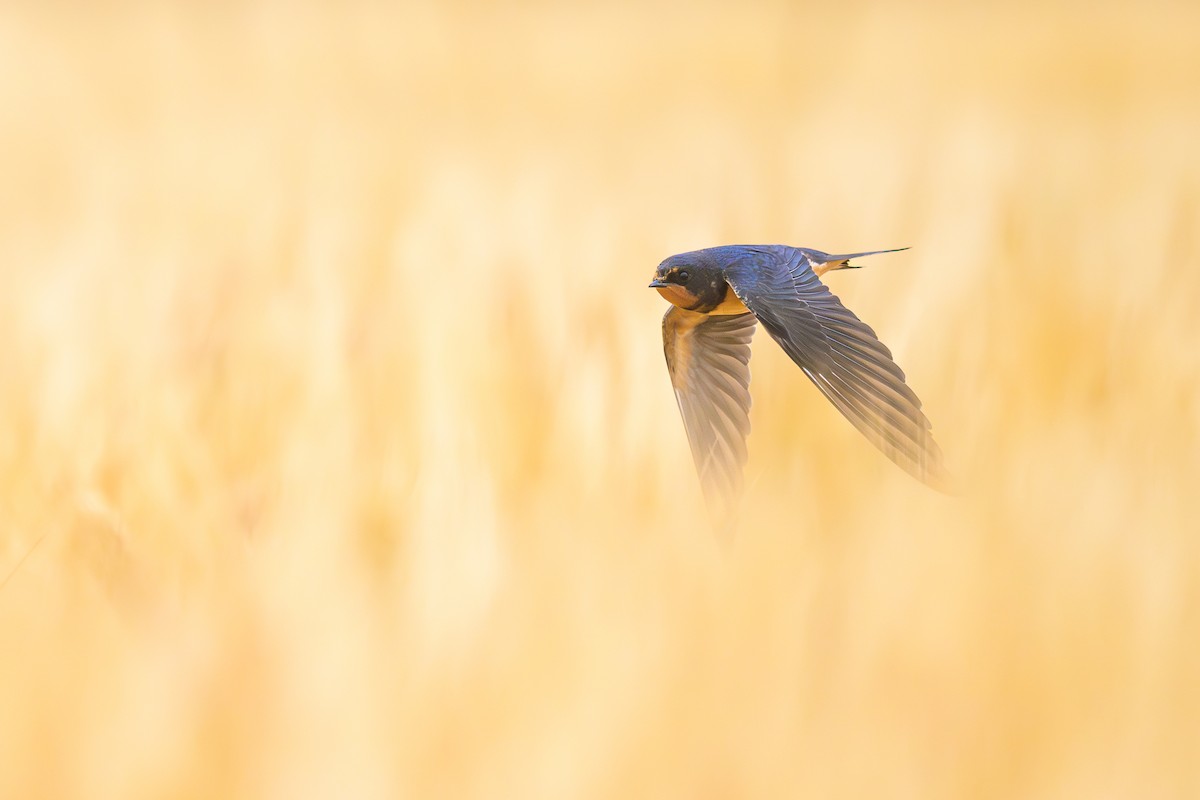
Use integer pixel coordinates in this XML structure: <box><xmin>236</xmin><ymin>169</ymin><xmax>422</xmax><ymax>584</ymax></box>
<box><xmin>650</xmin><ymin>245</ymin><xmax>949</xmax><ymax>520</ymax></box>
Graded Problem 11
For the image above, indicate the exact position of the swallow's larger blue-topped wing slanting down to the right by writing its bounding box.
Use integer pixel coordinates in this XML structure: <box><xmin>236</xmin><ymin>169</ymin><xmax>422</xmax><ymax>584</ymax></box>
<box><xmin>726</xmin><ymin>248</ymin><xmax>949</xmax><ymax>491</ymax></box>
